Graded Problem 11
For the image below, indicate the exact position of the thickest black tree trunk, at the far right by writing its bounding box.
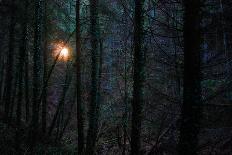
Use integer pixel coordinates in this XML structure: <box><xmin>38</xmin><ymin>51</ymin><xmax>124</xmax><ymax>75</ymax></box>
<box><xmin>178</xmin><ymin>0</ymin><xmax>202</xmax><ymax>155</ymax></box>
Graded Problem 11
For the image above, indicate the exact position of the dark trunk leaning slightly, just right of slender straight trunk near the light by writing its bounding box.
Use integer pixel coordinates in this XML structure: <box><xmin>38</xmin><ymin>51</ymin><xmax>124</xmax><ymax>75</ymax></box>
<box><xmin>85</xmin><ymin>0</ymin><xmax>99</xmax><ymax>155</ymax></box>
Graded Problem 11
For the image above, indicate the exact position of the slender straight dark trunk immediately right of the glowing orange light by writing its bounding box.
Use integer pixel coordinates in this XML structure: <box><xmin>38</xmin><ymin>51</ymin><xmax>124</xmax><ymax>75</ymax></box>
<box><xmin>76</xmin><ymin>0</ymin><xmax>84</xmax><ymax>155</ymax></box>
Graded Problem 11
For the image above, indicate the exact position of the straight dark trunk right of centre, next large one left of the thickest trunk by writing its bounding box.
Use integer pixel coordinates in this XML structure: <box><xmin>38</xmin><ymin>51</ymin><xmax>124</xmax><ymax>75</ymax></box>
<box><xmin>131</xmin><ymin>0</ymin><xmax>144</xmax><ymax>155</ymax></box>
